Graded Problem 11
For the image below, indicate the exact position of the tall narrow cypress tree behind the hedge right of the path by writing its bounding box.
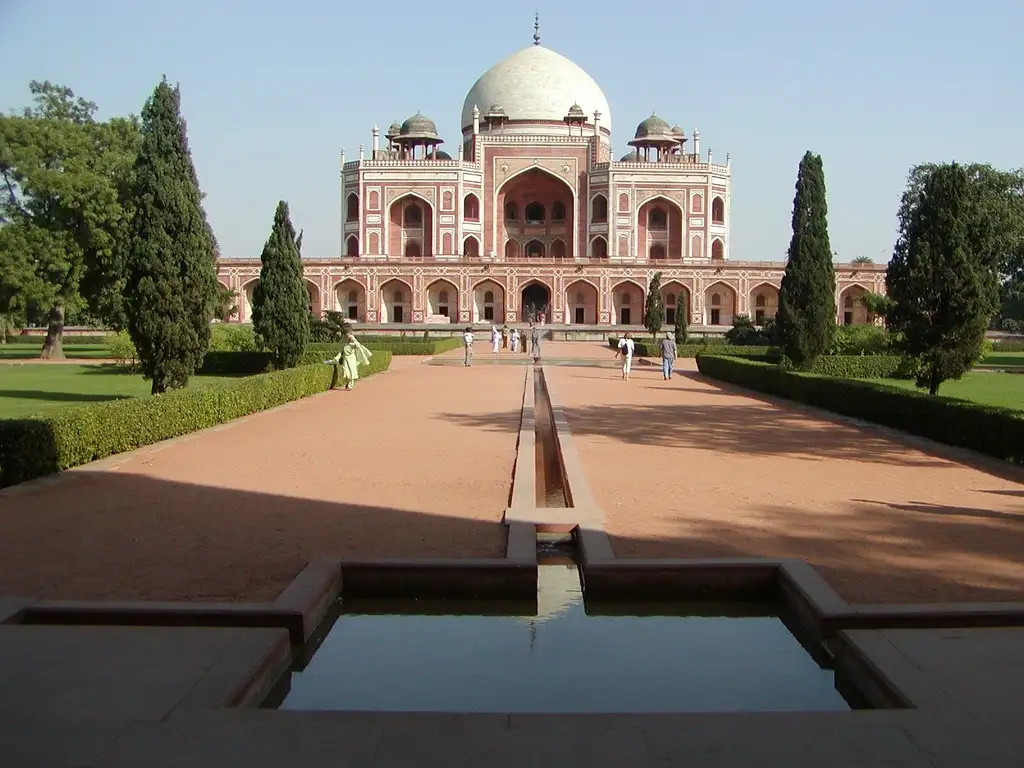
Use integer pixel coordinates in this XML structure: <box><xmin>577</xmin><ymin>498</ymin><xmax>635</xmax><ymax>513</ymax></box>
<box><xmin>775</xmin><ymin>152</ymin><xmax>836</xmax><ymax>369</ymax></box>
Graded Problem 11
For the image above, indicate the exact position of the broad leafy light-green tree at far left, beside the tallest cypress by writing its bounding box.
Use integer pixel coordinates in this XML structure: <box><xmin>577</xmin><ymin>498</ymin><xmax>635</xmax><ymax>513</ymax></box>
<box><xmin>0</xmin><ymin>81</ymin><xmax>138</xmax><ymax>358</ymax></box>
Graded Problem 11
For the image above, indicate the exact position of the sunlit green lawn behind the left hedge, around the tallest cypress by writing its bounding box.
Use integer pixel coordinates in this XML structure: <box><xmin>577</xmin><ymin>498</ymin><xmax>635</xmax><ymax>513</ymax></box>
<box><xmin>0</xmin><ymin>364</ymin><xmax>233</xmax><ymax>419</ymax></box>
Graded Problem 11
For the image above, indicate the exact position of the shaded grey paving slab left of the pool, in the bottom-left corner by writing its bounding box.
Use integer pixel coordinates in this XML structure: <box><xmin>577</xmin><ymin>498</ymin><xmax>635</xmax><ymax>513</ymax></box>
<box><xmin>0</xmin><ymin>625</ymin><xmax>286</xmax><ymax>768</ymax></box>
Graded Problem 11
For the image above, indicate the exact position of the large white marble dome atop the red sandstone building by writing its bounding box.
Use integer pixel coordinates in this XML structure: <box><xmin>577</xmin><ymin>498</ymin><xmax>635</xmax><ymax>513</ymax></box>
<box><xmin>462</xmin><ymin>45</ymin><xmax>611</xmax><ymax>132</ymax></box>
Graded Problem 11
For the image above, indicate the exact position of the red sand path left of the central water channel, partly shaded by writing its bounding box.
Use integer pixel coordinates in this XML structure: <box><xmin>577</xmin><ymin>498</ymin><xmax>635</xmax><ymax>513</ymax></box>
<box><xmin>0</xmin><ymin>358</ymin><xmax>525</xmax><ymax>601</ymax></box>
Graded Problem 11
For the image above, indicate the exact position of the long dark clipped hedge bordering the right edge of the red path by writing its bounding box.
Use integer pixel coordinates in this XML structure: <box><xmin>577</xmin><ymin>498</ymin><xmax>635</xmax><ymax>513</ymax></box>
<box><xmin>697</xmin><ymin>355</ymin><xmax>1024</xmax><ymax>464</ymax></box>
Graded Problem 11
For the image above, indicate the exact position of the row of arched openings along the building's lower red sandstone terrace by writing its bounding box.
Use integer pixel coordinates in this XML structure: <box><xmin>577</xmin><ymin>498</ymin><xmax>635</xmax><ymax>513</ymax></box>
<box><xmin>221</xmin><ymin>278</ymin><xmax>870</xmax><ymax>327</ymax></box>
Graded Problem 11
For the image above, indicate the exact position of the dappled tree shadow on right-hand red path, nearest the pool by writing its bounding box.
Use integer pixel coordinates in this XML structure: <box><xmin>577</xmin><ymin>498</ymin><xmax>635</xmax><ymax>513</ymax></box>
<box><xmin>609</xmin><ymin>502</ymin><xmax>1024</xmax><ymax>603</ymax></box>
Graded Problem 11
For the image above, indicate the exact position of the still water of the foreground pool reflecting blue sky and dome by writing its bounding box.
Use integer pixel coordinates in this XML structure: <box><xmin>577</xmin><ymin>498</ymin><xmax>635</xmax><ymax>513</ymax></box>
<box><xmin>281</xmin><ymin>564</ymin><xmax>849</xmax><ymax>713</ymax></box>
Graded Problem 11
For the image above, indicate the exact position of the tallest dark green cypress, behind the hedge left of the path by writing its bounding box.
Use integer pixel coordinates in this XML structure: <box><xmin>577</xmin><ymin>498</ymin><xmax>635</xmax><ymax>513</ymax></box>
<box><xmin>125</xmin><ymin>78</ymin><xmax>217</xmax><ymax>394</ymax></box>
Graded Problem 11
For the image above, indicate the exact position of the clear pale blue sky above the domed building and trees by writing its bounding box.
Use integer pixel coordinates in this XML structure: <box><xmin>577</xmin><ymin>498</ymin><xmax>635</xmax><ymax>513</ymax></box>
<box><xmin>0</xmin><ymin>0</ymin><xmax>1024</xmax><ymax>261</ymax></box>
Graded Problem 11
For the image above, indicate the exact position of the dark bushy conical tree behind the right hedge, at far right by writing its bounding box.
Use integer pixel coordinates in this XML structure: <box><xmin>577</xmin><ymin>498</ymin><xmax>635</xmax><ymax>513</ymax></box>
<box><xmin>886</xmin><ymin>163</ymin><xmax>1000</xmax><ymax>394</ymax></box>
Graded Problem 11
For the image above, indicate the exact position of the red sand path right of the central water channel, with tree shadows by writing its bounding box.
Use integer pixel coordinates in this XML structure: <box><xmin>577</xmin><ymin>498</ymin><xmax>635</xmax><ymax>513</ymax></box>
<box><xmin>548</xmin><ymin>360</ymin><xmax>1024</xmax><ymax>602</ymax></box>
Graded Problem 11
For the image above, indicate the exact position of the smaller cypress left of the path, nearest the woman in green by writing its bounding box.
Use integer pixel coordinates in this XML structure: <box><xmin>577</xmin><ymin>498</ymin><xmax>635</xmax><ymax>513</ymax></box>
<box><xmin>253</xmin><ymin>201</ymin><xmax>309</xmax><ymax>368</ymax></box>
